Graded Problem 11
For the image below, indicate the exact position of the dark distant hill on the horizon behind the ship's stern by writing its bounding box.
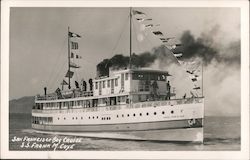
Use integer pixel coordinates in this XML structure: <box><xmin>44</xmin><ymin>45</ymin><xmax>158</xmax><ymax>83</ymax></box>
<box><xmin>9</xmin><ymin>96</ymin><xmax>35</xmax><ymax>113</ymax></box>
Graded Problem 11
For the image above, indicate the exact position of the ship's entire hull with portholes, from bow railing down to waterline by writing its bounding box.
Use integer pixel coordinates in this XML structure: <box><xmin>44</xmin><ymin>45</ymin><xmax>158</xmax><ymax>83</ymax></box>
<box><xmin>32</xmin><ymin>99</ymin><xmax>204</xmax><ymax>143</ymax></box>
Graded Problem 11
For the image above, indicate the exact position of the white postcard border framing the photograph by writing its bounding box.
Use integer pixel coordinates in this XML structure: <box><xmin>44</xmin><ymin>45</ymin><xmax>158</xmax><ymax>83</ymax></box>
<box><xmin>1</xmin><ymin>0</ymin><xmax>249</xmax><ymax>159</ymax></box>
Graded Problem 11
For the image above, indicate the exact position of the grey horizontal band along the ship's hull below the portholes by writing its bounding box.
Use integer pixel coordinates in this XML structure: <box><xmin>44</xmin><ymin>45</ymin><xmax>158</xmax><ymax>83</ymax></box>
<box><xmin>32</xmin><ymin>118</ymin><xmax>203</xmax><ymax>132</ymax></box>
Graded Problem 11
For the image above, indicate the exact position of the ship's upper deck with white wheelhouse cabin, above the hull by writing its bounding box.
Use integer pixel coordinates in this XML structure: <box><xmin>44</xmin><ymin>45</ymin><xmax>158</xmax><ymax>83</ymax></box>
<box><xmin>36</xmin><ymin>68</ymin><xmax>170</xmax><ymax>101</ymax></box>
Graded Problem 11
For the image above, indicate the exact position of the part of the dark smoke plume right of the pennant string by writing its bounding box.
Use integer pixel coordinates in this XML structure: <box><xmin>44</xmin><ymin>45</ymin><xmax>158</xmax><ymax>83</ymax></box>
<box><xmin>172</xmin><ymin>27</ymin><xmax>240</xmax><ymax>65</ymax></box>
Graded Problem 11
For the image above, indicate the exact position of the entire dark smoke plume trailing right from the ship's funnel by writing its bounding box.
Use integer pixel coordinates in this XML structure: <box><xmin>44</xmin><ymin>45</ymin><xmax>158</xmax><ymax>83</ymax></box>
<box><xmin>97</xmin><ymin>26</ymin><xmax>240</xmax><ymax>76</ymax></box>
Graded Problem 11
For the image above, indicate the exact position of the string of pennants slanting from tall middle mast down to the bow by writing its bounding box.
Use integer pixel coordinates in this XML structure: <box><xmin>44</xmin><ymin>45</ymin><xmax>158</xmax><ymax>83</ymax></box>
<box><xmin>132</xmin><ymin>10</ymin><xmax>201</xmax><ymax>94</ymax></box>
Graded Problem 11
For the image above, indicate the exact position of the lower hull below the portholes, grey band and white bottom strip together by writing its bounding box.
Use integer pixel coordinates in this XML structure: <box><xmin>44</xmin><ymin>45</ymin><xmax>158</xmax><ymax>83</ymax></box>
<box><xmin>32</xmin><ymin>119</ymin><xmax>203</xmax><ymax>143</ymax></box>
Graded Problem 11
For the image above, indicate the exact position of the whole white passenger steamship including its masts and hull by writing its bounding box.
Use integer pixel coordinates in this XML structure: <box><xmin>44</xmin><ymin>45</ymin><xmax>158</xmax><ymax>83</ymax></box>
<box><xmin>32</xmin><ymin>9</ymin><xmax>204</xmax><ymax>142</ymax></box>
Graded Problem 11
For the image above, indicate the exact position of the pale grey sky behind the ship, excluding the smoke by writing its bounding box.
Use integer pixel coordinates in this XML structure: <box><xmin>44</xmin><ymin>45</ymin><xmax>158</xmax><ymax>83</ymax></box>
<box><xmin>9</xmin><ymin>8</ymin><xmax>240</xmax><ymax>115</ymax></box>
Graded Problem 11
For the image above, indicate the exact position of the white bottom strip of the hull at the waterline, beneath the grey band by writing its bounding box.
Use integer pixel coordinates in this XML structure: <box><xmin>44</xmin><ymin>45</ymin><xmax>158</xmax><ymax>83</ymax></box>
<box><xmin>32</xmin><ymin>127</ymin><xmax>203</xmax><ymax>143</ymax></box>
